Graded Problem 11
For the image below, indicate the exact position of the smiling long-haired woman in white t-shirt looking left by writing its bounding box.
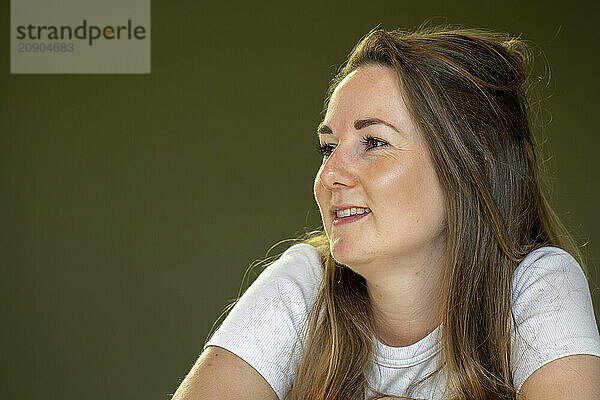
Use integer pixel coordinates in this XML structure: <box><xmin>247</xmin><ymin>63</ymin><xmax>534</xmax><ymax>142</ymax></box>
<box><xmin>174</xmin><ymin>28</ymin><xmax>600</xmax><ymax>400</ymax></box>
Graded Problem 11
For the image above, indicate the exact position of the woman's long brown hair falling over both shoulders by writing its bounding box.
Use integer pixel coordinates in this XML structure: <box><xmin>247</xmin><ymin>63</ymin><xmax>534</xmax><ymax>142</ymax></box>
<box><xmin>286</xmin><ymin>27</ymin><xmax>583</xmax><ymax>400</ymax></box>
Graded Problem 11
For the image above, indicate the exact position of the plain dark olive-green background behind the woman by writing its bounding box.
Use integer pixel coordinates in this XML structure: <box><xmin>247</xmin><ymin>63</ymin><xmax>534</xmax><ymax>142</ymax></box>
<box><xmin>0</xmin><ymin>0</ymin><xmax>600</xmax><ymax>400</ymax></box>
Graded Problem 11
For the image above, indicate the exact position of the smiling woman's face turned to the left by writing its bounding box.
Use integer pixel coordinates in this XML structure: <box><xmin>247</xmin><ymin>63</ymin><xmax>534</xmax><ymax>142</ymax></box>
<box><xmin>314</xmin><ymin>66</ymin><xmax>445</xmax><ymax>274</ymax></box>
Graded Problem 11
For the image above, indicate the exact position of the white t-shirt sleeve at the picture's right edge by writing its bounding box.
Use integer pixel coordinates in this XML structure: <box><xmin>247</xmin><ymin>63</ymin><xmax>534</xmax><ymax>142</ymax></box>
<box><xmin>511</xmin><ymin>247</ymin><xmax>600</xmax><ymax>390</ymax></box>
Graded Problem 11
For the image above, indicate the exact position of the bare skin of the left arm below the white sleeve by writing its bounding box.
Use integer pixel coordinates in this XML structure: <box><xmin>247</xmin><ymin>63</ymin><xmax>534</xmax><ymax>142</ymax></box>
<box><xmin>172</xmin><ymin>346</ymin><xmax>278</xmax><ymax>400</ymax></box>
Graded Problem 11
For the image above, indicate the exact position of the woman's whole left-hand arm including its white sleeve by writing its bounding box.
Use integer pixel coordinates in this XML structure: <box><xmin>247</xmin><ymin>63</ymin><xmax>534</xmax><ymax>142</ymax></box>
<box><xmin>173</xmin><ymin>244</ymin><xmax>322</xmax><ymax>400</ymax></box>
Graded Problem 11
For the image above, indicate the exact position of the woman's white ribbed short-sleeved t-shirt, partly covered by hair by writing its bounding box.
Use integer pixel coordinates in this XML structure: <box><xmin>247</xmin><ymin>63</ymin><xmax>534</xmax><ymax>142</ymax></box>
<box><xmin>204</xmin><ymin>244</ymin><xmax>600</xmax><ymax>400</ymax></box>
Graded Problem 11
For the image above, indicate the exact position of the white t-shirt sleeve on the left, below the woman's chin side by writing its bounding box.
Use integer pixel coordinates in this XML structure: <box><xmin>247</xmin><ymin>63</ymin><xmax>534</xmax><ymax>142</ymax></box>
<box><xmin>204</xmin><ymin>244</ymin><xmax>322</xmax><ymax>399</ymax></box>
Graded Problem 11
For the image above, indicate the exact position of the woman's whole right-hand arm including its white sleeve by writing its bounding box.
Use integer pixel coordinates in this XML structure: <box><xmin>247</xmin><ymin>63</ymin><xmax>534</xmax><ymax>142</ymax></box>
<box><xmin>511</xmin><ymin>247</ymin><xmax>600</xmax><ymax>400</ymax></box>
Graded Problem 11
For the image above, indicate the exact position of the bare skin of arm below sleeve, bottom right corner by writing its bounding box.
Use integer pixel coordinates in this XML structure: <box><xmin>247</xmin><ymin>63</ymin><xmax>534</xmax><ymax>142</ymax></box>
<box><xmin>518</xmin><ymin>354</ymin><xmax>600</xmax><ymax>400</ymax></box>
